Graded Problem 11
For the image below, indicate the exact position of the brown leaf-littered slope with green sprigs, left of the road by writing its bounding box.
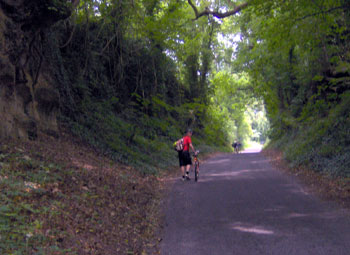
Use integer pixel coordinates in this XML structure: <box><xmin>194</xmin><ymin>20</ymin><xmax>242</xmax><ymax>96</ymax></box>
<box><xmin>0</xmin><ymin>132</ymin><xmax>162</xmax><ymax>255</ymax></box>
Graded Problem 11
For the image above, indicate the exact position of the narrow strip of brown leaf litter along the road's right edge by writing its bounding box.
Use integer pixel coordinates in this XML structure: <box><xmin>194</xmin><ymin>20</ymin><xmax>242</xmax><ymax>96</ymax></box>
<box><xmin>262</xmin><ymin>149</ymin><xmax>350</xmax><ymax>208</ymax></box>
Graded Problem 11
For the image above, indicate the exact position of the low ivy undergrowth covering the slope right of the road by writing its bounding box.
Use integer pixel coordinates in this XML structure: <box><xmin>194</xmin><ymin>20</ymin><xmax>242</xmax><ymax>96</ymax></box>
<box><xmin>270</xmin><ymin>93</ymin><xmax>350</xmax><ymax>177</ymax></box>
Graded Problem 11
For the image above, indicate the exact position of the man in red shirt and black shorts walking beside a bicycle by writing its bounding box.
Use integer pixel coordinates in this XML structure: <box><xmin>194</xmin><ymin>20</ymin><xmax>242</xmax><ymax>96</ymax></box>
<box><xmin>179</xmin><ymin>129</ymin><xmax>196</xmax><ymax>180</ymax></box>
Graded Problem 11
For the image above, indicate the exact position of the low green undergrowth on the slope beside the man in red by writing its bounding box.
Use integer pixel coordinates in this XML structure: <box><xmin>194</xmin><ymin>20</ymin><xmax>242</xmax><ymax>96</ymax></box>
<box><xmin>61</xmin><ymin>97</ymin><xmax>230</xmax><ymax>175</ymax></box>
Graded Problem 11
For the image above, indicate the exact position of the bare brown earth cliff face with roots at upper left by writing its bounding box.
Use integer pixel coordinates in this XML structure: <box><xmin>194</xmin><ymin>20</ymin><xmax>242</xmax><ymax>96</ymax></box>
<box><xmin>0</xmin><ymin>0</ymin><xmax>79</xmax><ymax>140</ymax></box>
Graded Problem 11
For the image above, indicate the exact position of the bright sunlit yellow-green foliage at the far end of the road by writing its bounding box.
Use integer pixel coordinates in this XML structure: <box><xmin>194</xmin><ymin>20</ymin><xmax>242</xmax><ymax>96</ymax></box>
<box><xmin>205</xmin><ymin>71</ymin><xmax>268</xmax><ymax>148</ymax></box>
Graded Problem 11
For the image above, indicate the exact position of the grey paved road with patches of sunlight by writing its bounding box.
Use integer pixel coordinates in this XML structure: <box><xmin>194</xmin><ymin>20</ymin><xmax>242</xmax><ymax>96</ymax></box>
<box><xmin>161</xmin><ymin>151</ymin><xmax>350</xmax><ymax>255</ymax></box>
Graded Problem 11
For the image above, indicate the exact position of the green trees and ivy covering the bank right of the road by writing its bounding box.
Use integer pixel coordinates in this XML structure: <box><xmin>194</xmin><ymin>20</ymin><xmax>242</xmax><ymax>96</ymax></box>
<box><xmin>235</xmin><ymin>0</ymin><xmax>350</xmax><ymax>176</ymax></box>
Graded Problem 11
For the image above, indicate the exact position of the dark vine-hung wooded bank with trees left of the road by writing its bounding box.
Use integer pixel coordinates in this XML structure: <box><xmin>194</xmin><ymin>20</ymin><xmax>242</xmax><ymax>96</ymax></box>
<box><xmin>50</xmin><ymin>0</ymin><xmax>235</xmax><ymax>174</ymax></box>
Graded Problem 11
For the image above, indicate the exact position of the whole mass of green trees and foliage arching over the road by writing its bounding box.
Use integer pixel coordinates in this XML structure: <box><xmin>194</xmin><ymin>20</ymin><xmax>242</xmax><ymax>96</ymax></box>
<box><xmin>1</xmin><ymin>0</ymin><xmax>350</xmax><ymax>174</ymax></box>
